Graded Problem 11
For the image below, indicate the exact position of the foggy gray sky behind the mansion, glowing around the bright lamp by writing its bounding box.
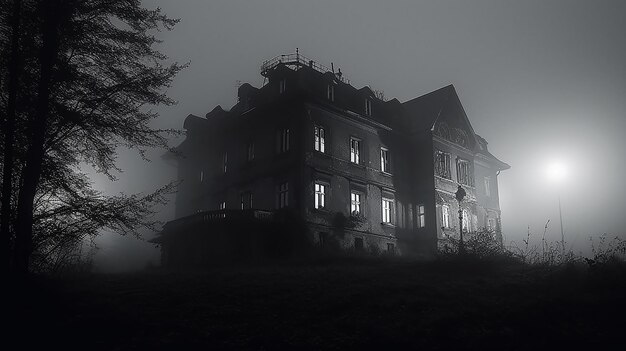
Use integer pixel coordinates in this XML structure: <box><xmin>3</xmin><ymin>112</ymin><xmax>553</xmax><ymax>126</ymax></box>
<box><xmin>90</xmin><ymin>0</ymin><xmax>626</xmax><ymax>270</ymax></box>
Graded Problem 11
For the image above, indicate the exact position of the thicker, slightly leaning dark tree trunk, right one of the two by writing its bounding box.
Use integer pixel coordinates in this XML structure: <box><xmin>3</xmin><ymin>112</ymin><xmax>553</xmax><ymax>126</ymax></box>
<box><xmin>13</xmin><ymin>0</ymin><xmax>62</xmax><ymax>274</ymax></box>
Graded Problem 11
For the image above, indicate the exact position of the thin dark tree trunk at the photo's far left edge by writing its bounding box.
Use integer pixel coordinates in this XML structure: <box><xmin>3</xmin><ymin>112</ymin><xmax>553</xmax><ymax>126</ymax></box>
<box><xmin>0</xmin><ymin>0</ymin><xmax>22</xmax><ymax>273</ymax></box>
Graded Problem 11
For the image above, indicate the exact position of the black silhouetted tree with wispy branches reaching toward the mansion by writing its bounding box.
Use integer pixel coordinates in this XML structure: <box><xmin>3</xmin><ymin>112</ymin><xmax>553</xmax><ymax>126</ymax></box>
<box><xmin>0</xmin><ymin>0</ymin><xmax>184</xmax><ymax>272</ymax></box>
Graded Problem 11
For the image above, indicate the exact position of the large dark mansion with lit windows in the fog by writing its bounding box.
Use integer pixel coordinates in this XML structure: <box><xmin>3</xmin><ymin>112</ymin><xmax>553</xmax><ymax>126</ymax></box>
<box><xmin>154</xmin><ymin>54</ymin><xmax>509</xmax><ymax>264</ymax></box>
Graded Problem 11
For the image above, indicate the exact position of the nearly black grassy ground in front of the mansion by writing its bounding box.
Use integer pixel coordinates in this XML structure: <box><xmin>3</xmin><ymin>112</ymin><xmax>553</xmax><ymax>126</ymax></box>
<box><xmin>4</xmin><ymin>259</ymin><xmax>626</xmax><ymax>350</ymax></box>
